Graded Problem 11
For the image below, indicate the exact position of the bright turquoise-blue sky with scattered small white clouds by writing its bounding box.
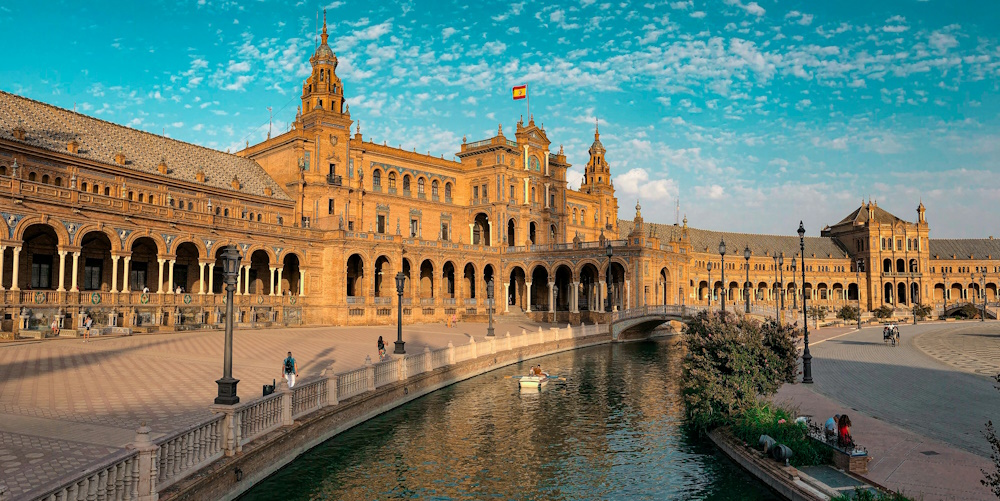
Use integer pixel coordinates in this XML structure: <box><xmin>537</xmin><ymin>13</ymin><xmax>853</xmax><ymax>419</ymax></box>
<box><xmin>0</xmin><ymin>0</ymin><xmax>1000</xmax><ymax>238</ymax></box>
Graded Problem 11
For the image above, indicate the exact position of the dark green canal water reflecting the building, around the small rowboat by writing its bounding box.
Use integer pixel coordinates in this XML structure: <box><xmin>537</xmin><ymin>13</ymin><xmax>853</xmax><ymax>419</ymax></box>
<box><xmin>240</xmin><ymin>340</ymin><xmax>776</xmax><ymax>501</ymax></box>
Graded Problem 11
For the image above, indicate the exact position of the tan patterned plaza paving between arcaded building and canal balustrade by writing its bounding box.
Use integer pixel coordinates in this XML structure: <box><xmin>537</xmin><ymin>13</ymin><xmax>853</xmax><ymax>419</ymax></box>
<box><xmin>0</xmin><ymin>320</ymin><xmax>547</xmax><ymax>499</ymax></box>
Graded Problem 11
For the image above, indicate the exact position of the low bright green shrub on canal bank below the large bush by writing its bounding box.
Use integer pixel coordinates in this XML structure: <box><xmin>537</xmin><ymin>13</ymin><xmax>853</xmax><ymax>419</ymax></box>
<box><xmin>731</xmin><ymin>403</ymin><xmax>833</xmax><ymax>466</ymax></box>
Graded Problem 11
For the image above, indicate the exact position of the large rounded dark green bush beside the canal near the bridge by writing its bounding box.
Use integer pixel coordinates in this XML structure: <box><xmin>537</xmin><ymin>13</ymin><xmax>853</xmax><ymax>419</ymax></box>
<box><xmin>682</xmin><ymin>312</ymin><xmax>798</xmax><ymax>431</ymax></box>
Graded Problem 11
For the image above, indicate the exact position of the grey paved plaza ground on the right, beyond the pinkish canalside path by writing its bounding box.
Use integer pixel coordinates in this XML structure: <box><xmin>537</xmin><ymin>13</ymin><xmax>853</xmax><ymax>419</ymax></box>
<box><xmin>810</xmin><ymin>322</ymin><xmax>1000</xmax><ymax>458</ymax></box>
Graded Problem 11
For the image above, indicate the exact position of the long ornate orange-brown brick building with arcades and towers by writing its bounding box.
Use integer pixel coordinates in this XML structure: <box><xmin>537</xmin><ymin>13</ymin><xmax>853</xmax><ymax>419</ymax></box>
<box><xmin>0</xmin><ymin>18</ymin><xmax>1000</xmax><ymax>335</ymax></box>
